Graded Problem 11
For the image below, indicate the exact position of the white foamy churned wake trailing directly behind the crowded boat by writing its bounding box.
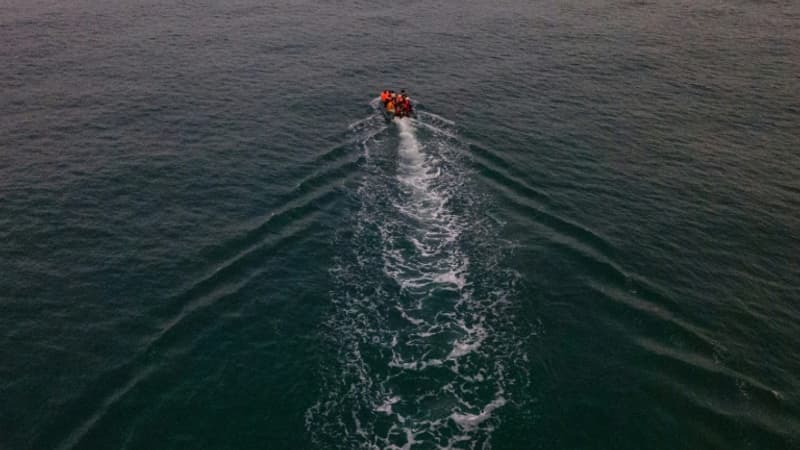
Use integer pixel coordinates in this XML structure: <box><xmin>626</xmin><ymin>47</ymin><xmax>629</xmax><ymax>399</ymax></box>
<box><xmin>306</xmin><ymin>114</ymin><xmax>525</xmax><ymax>449</ymax></box>
